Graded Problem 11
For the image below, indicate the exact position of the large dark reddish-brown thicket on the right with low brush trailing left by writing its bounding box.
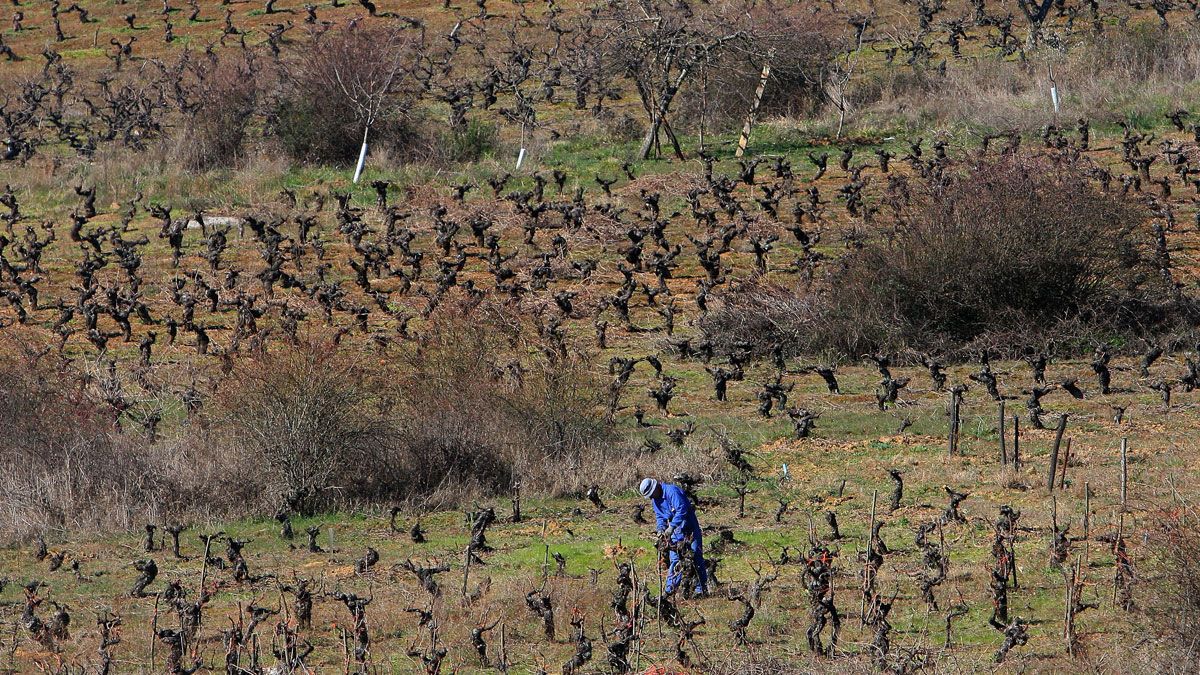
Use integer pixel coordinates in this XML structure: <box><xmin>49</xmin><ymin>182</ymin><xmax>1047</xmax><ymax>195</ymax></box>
<box><xmin>703</xmin><ymin>157</ymin><xmax>1194</xmax><ymax>357</ymax></box>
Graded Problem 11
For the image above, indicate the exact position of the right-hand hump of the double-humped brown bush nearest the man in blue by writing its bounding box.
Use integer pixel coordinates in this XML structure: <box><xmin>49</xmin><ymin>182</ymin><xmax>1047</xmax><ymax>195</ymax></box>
<box><xmin>398</xmin><ymin>307</ymin><xmax>614</xmax><ymax>502</ymax></box>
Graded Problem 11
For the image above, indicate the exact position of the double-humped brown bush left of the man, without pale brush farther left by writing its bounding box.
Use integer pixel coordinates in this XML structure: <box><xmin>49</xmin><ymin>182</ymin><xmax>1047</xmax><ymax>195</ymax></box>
<box><xmin>209</xmin><ymin>311</ymin><xmax>635</xmax><ymax>513</ymax></box>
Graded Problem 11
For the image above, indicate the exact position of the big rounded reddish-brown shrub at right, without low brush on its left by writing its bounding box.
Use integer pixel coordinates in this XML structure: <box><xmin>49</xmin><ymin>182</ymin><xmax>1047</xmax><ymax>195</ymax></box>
<box><xmin>827</xmin><ymin>153</ymin><xmax>1168</xmax><ymax>350</ymax></box>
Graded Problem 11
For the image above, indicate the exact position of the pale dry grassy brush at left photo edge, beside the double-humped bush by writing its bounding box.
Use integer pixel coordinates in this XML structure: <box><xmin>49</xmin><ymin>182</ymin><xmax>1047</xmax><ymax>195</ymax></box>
<box><xmin>0</xmin><ymin>341</ymin><xmax>296</xmax><ymax>542</ymax></box>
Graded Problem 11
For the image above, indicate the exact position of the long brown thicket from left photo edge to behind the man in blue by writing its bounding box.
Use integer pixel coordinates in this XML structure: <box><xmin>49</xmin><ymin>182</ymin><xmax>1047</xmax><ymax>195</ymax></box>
<box><xmin>0</xmin><ymin>312</ymin><xmax>707</xmax><ymax>538</ymax></box>
